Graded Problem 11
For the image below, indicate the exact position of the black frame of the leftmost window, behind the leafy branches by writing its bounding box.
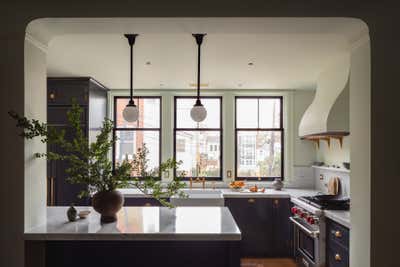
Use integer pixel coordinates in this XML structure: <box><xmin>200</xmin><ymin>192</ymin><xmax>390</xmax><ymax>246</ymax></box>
<box><xmin>112</xmin><ymin>96</ymin><xmax>162</xmax><ymax>180</ymax></box>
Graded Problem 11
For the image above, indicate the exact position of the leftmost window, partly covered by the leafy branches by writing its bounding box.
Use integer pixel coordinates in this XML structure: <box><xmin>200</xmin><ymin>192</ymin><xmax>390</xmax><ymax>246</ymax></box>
<box><xmin>113</xmin><ymin>96</ymin><xmax>161</xmax><ymax>176</ymax></box>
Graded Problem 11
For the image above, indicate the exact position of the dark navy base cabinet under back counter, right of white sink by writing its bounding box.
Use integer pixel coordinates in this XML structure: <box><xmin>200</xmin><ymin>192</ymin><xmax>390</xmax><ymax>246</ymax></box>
<box><xmin>225</xmin><ymin>198</ymin><xmax>292</xmax><ymax>257</ymax></box>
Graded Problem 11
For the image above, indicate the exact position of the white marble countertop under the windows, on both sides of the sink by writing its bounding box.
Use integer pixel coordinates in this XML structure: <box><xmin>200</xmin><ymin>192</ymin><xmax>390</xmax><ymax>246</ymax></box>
<box><xmin>118</xmin><ymin>188</ymin><xmax>318</xmax><ymax>198</ymax></box>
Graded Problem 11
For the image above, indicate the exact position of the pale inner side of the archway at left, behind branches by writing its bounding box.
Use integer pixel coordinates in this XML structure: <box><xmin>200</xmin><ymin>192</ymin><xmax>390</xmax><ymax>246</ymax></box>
<box><xmin>24</xmin><ymin>38</ymin><xmax>47</xmax><ymax>229</ymax></box>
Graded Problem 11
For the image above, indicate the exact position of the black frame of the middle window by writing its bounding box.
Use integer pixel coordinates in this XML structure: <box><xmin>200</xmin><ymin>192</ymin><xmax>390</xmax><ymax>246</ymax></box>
<box><xmin>173</xmin><ymin>96</ymin><xmax>224</xmax><ymax>181</ymax></box>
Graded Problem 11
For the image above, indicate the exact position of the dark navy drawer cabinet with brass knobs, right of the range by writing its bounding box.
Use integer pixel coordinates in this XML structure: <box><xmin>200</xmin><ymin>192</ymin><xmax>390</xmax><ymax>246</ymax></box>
<box><xmin>326</xmin><ymin>219</ymin><xmax>350</xmax><ymax>267</ymax></box>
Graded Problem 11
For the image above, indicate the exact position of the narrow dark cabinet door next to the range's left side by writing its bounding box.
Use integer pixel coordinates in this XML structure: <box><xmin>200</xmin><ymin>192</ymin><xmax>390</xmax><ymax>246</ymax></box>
<box><xmin>272</xmin><ymin>198</ymin><xmax>293</xmax><ymax>257</ymax></box>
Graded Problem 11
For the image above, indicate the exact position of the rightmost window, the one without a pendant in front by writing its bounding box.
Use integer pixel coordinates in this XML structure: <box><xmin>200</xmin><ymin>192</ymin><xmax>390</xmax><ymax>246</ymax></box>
<box><xmin>235</xmin><ymin>96</ymin><xmax>284</xmax><ymax>180</ymax></box>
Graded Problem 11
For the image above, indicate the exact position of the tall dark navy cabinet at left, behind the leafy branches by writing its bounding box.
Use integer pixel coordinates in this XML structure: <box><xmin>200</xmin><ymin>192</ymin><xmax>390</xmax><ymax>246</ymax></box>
<box><xmin>47</xmin><ymin>77</ymin><xmax>108</xmax><ymax>206</ymax></box>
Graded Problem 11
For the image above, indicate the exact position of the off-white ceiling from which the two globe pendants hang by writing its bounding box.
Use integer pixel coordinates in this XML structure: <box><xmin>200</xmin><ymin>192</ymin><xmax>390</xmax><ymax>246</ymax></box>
<box><xmin>28</xmin><ymin>18</ymin><xmax>366</xmax><ymax>89</ymax></box>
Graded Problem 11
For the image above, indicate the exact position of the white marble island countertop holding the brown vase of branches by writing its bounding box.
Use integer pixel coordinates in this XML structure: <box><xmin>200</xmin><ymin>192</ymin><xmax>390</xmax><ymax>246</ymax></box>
<box><xmin>24</xmin><ymin>207</ymin><xmax>241</xmax><ymax>241</ymax></box>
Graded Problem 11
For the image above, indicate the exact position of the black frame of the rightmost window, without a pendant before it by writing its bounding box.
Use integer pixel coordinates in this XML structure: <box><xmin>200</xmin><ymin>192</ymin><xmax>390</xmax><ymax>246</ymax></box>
<box><xmin>235</xmin><ymin>96</ymin><xmax>285</xmax><ymax>181</ymax></box>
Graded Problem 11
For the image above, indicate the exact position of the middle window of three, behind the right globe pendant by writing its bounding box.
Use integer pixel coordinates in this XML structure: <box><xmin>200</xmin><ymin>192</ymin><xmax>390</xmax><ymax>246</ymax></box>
<box><xmin>174</xmin><ymin>97</ymin><xmax>222</xmax><ymax>180</ymax></box>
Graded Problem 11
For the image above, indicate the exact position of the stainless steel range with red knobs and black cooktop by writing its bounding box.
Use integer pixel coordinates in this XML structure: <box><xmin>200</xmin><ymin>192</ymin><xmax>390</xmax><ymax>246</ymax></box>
<box><xmin>289</xmin><ymin>195</ymin><xmax>350</xmax><ymax>267</ymax></box>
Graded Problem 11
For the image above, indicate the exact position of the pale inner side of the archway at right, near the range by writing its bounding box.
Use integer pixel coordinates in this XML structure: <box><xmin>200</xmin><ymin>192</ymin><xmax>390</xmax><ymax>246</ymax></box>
<box><xmin>350</xmin><ymin>38</ymin><xmax>372</xmax><ymax>267</ymax></box>
